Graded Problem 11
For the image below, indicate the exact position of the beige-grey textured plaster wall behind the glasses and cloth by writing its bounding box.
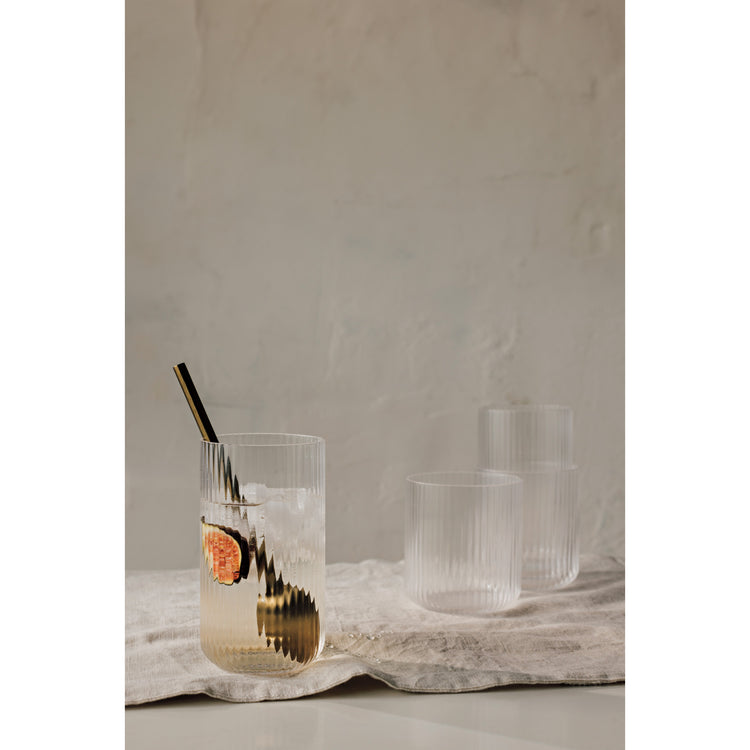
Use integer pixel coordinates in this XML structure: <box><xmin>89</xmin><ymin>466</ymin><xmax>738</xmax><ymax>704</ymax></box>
<box><xmin>126</xmin><ymin>0</ymin><xmax>624</xmax><ymax>568</ymax></box>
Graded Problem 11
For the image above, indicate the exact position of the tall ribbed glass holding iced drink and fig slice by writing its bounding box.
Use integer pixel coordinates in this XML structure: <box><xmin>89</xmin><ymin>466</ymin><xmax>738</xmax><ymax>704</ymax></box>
<box><xmin>200</xmin><ymin>434</ymin><xmax>325</xmax><ymax>674</ymax></box>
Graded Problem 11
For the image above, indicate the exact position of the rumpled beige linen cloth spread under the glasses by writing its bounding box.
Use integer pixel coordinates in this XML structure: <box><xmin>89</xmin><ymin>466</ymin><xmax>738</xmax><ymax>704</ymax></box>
<box><xmin>125</xmin><ymin>555</ymin><xmax>625</xmax><ymax>705</ymax></box>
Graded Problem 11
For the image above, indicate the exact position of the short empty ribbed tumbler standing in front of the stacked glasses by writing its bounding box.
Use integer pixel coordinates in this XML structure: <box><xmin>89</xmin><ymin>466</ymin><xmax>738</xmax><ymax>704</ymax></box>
<box><xmin>404</xmin><ymin>471</ymin><xmax>522</xmax><ymax>615</ymax></box>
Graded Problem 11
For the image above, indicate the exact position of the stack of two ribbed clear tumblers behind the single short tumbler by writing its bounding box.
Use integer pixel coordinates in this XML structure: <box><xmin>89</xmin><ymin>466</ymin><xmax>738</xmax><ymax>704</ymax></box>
<box><xmin>479</xmin><ymin>405</ymin><xmax>578</xmax><ymax>591</ymax></box>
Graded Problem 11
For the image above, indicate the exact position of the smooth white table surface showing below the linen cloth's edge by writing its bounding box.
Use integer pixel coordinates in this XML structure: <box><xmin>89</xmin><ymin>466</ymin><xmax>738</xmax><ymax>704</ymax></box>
<box><xmin>125</xmin><ymin>677</ymin><xmax>625</xmax><ymax>750</ymax></box>
